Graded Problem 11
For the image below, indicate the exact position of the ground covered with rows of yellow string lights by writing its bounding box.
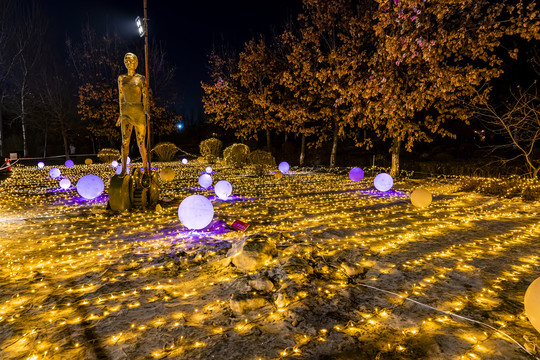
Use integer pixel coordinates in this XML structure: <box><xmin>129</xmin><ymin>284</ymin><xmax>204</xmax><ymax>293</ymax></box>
<box><xmin>0</xmin><ymin>163</ymin><xmax>540</xmax><ymax>360</ymax></box>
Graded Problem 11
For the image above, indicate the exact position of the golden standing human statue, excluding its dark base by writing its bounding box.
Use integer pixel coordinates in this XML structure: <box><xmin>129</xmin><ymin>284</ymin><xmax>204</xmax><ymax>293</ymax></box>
<box><xmin>116</xmin><ymin>53</ymin><xmax>150</xmax><ymax>176</ymax></box>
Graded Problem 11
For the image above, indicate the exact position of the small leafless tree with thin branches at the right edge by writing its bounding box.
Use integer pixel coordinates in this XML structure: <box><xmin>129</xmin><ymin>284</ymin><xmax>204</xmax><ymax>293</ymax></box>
<box><xmin>476</xmin><ymin>81</ymin><xmax>540</xmax><ymax>179</ymax></box>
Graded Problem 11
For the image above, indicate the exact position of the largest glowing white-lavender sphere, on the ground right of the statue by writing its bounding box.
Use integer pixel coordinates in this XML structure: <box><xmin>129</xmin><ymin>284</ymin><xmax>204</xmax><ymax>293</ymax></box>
<box><xmin>178</xmin><ymin>195</ymin><xmax>214</xmax><ymax>230</ymax></box>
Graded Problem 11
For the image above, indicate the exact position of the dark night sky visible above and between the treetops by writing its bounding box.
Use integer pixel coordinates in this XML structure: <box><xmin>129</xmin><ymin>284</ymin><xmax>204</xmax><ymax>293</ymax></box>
<box><xmin>39</xmin><ymin>0</ymin><xmax>301</xmax><ymax>115</ymax></box>
